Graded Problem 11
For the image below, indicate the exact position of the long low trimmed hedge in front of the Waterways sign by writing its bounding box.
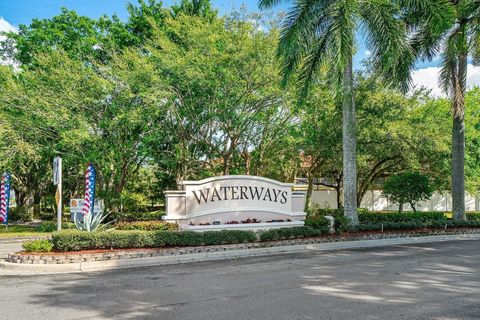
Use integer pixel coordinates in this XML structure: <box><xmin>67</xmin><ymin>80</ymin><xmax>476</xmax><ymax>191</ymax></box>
<box><xmin>52</xmin><ymin>230</ymin><xmax>256</xmax><ymax>251</ymax></box>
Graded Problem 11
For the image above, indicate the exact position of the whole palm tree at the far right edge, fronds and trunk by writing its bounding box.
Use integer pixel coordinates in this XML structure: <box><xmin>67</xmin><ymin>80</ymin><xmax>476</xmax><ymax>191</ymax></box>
<box><xmin>401</xmin><ymin>0</ymin><xmax>480</xmax><ymax>220</ymax></box>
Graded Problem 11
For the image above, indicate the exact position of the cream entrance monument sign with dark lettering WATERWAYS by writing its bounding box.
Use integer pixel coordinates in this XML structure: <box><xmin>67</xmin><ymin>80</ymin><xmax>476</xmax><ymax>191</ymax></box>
<box><xmin>164</xmin><ymin>175</ymin><xmax>306</xmax><ymax>229</ymax></box>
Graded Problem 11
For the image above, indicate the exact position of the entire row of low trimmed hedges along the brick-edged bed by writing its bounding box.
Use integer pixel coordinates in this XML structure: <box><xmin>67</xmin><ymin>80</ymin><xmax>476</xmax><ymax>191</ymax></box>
<box><xmin>27</xmin><ymin>220</ymin><xmax>480</xmax><ymax>252</ymax></box>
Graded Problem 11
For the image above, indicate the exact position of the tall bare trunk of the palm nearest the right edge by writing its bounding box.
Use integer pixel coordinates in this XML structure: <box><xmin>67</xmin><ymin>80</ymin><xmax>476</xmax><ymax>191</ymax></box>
<box><xmin>452</xmin><ymin>55</ymin><xmax>467</xmax><ymax>220</ymax></box>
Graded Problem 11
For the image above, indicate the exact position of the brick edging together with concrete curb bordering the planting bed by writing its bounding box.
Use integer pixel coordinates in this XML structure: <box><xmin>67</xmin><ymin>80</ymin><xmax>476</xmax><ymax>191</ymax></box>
<box><xmin>0</xmin><ymin>229</ymin><xmax>480</xmax><ymax>274</ymax></box>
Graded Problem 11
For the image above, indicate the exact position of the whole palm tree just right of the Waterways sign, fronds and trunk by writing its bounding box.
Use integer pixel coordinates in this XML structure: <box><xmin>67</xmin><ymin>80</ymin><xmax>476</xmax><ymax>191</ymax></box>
<box><xmin>259</xmin><ymin>0</ymin><xmax>408</xmax><ymax>224</ymax></box>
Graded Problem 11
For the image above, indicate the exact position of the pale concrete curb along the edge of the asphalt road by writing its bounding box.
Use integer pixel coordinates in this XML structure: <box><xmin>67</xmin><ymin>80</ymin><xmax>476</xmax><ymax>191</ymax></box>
<box><xmin>0</xmin><ymin>234</ymin><xmax>480</xmax><ymax>275</ymax></box>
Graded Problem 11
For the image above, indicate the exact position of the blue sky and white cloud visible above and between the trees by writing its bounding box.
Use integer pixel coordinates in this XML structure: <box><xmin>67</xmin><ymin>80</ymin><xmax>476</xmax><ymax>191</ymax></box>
<box><xmin>0</xmin><ymin>0</ymin><xmax>480</xmax><ymax>96</ymax></box>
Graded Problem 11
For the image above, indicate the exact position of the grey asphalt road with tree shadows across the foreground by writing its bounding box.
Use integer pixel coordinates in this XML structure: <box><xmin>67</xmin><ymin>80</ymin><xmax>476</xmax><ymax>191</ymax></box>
<box><xmin>0</xmin><ymin>240</ymin><xmax>480</xmax><ymax>320</ymax></box>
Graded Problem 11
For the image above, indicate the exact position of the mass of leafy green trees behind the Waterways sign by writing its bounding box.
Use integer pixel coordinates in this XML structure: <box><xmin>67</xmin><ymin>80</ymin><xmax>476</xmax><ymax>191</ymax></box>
<box><xmin>0</xmin><ymin>0</ymin><xmax>480</xmax><ymax>221</ymax></box>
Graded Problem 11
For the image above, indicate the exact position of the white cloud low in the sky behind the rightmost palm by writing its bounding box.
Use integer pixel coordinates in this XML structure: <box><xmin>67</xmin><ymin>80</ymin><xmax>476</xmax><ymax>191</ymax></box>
<box><xmin>412</xmin><ymin>64</ymin><xmax>480</xmax><ymax>97</ymax></box>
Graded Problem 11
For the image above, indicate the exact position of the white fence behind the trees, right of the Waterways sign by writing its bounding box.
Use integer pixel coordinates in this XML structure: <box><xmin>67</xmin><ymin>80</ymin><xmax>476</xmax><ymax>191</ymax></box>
<box><xmin>311</xmin><ymin>190</ymin><xmax>480</xmax><ymax>211</ymax></box>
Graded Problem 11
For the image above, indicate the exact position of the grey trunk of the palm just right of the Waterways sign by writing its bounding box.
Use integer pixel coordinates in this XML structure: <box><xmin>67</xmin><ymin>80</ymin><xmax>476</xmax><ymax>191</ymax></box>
<box><xmin>342</xmin><ymin>57</ymin><xmax>358</xmax><ymax>225</ymax></box>
